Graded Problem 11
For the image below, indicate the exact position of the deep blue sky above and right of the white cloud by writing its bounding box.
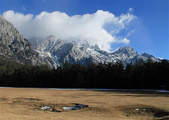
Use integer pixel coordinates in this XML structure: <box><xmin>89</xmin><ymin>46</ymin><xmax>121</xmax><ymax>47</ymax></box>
<box><xmin>0</xmin><ymin>0</ymin><xmax>169</xmax><ymax>59</ymax></box>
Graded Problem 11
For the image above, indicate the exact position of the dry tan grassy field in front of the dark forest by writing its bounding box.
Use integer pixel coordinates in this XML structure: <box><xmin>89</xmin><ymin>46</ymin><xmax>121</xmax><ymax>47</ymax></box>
<box><xmin>0</xmin><ymin>88</ymin><xmax>169</xmax><ymax>120</ymax></box>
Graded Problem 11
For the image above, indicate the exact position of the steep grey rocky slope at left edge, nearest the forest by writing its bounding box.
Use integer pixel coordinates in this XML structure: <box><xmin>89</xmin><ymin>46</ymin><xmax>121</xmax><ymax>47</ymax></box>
<box><xmin>0</xmin><ymin>16</ymin><xmax>43</xmax><ymax>65</ymax></box>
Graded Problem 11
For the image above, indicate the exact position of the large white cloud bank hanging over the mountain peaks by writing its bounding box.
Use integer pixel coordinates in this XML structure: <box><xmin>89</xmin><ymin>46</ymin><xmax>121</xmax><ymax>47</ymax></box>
<box><xmin>2</xmin><ymin>9</ymin><xmax>136</xmax><ymax>51</ymax></box>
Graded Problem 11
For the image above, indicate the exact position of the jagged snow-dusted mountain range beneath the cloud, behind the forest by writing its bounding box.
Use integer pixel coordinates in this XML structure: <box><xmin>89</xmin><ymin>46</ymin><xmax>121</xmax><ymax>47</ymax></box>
<box><xmin>31</xmin><ymin>35</ymin><xmax>160</xmax><ymax>66</ymax></box>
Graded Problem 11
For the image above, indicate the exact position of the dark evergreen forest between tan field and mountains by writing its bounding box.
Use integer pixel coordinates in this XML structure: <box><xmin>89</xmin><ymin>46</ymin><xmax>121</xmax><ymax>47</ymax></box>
<box><xmin>0</xmin><ymin>60</ymin><xmax>169</xmax><ymax>90</ymax></box>
